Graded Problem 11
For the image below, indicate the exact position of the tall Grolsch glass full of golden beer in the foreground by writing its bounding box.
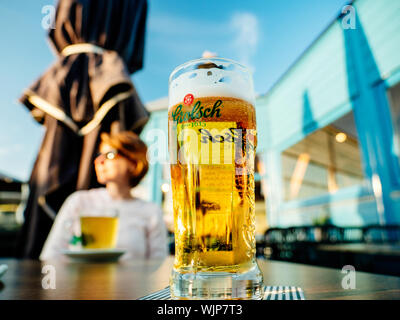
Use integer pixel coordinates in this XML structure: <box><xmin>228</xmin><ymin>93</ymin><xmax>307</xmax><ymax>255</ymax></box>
<box><xmin>168</xmin><ymin>58</ymin><xmax>263</xmax><ymax>299</ymax></box>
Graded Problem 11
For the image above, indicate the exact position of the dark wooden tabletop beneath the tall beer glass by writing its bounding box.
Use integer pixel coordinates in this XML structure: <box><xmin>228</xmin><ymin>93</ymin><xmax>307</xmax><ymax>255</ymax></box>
<box><xmin>0</xmin><ymin>257</ymin><xmax>400</xmax><ymax>300</ymax></box>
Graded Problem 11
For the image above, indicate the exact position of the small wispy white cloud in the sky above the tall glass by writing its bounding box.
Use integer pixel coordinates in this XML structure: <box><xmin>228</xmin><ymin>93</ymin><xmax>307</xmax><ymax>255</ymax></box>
<box><xmin>230</xmin><ymin>12</ymin><xmax>259</xmax><ymax>68</ymax></box>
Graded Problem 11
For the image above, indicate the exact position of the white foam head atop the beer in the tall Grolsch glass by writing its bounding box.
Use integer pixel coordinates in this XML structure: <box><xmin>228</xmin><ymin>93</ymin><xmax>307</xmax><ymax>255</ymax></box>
<box><xmin>169</xmin><ymin>58</ymin><xmax>255</xmax><ymax>108</ymax></box>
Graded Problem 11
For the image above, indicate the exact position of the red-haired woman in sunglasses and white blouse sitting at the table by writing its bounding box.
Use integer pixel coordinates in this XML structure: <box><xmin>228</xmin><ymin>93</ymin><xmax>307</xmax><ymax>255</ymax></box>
<box><xmin>40</xmin><ymin>131</ymin><xmax>167</xmax><ymax>260</ymax></box>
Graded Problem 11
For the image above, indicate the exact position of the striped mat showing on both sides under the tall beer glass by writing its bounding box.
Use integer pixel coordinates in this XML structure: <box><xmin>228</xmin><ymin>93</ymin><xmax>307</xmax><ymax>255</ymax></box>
<box><xmin>138</xmin><ymin>286</ymin><xmax>305</xmax><ymax>300</ymax></box>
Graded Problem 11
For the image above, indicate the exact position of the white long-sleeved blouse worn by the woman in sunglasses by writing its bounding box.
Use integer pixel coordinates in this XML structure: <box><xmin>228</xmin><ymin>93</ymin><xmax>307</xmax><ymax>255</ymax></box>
<box><xmin>40</xmin><ymin>188</ymin><xmax>168</xmax><ymax>260</ymax></box>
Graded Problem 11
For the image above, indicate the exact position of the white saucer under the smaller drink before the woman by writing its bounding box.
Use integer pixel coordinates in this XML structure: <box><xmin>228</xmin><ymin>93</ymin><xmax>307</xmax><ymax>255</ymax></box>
<box><xmin>63</xmin><ymin>249</ymin><xmax>126</xmax><ymax>262</ymax></box>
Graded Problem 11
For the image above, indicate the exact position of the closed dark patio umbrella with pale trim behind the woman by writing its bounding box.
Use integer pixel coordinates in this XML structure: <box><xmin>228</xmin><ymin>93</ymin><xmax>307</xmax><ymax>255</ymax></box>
<box><xmin>17</xmin><ymin>0</ymin><xmax>149</xmax><ymax>258</ymax></box>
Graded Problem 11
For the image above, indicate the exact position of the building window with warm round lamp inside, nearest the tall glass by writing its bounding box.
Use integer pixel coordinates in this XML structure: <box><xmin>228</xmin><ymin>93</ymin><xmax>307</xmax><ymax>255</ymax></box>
<box><xmin>282</xmin><ymin>112</ymin><xmax>364</xmax><ymax>201</ymax></box>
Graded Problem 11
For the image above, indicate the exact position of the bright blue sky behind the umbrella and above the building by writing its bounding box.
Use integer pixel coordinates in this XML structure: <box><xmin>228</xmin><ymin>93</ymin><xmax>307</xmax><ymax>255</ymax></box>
<box><xmin>0</xmin><ymin>0</ymin><xmax>348</xmax><ymax>180</ymax></box>
